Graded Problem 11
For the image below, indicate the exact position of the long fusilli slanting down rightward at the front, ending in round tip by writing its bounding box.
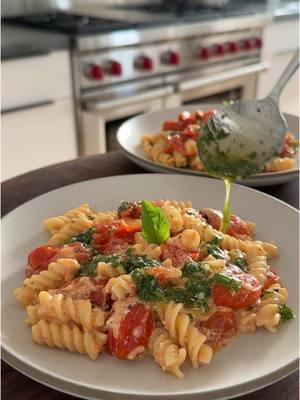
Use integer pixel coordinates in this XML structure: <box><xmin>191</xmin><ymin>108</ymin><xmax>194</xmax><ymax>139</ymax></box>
<box><xmin>159</xmin><ymin>302</ymin><xmax>213</xmax><ymax>368</ymax></box>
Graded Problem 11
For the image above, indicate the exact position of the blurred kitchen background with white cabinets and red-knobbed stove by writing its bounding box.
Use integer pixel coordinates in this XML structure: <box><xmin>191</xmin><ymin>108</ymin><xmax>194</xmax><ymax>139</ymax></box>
<box><xmin>1</xmin><ymin>0</ymin><xmax>299</xmax><ymax>180</ymax></box>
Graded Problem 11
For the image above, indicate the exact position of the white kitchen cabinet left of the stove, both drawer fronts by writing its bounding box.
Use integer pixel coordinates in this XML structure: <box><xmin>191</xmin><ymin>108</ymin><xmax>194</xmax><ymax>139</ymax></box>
<box><xmin>1</xmin><ymin>50</ymin><xmax>78</xmax><ymax>180</ymax></box>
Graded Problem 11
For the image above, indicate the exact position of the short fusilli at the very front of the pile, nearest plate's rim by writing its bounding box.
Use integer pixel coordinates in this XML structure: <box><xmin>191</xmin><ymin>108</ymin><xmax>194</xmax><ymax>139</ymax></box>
<box><xmin>148</xmin><ymin>328</ymin><xmax>186</xmax><ymax>378</ymax></box>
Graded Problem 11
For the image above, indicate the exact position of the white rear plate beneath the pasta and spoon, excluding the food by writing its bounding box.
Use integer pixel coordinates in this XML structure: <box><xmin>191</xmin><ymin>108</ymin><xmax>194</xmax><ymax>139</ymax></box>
<box><xmin>117</xmin><ymin>104</ymin><xmax>299</xmax><ymax>187</ymax></box>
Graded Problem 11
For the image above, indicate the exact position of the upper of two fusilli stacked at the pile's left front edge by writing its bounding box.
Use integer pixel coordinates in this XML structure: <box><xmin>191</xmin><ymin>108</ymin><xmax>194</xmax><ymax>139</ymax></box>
<box><xmin>27</xmin><ymin>291</ymin><xmax>105</xmax><ymax>330</ymax></box>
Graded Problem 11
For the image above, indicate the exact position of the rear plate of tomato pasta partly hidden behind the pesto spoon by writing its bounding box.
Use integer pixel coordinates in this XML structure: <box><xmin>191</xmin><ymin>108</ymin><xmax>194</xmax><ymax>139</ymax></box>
<box><xmin>117</xmin><ymin>104</ymin><xmax>299</xmax><ymax>187</ymax></box>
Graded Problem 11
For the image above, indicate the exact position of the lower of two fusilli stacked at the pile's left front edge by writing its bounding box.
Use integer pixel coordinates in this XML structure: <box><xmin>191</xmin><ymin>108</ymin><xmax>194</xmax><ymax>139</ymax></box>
<box><xmin>31</xmin><ymin>320</ymin><xmax>107</xmax><ymax>360</ymax></box>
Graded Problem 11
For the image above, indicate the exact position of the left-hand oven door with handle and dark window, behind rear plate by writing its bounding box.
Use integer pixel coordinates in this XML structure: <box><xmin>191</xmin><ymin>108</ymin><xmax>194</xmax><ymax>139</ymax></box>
<box><xmin>79</xmin><ymin>84</ymin><xmax>174</xmax><ymax>155</ymax></box>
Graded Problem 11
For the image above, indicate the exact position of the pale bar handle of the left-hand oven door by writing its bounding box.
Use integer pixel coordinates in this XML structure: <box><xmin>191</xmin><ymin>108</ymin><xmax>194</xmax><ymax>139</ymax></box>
<box><xmin>85</xmin><ymin>86</ymin><xmax>174</xmax><ymax>111</ymax></box>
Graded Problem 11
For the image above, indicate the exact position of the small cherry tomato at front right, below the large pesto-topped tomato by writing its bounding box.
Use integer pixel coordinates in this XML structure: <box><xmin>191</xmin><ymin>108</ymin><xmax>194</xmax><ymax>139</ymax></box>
<box><xmin>204</xmin><ymin>311</ymin><xmax>237</xmax><ymax>343</ymax></box>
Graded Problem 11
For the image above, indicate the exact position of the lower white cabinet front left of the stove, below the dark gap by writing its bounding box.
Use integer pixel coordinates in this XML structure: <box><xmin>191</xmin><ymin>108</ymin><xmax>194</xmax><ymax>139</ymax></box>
<box><xmin>1</xmin><ymin>100</ymin><xmax>77</xmax><ymax>180</ymax></box>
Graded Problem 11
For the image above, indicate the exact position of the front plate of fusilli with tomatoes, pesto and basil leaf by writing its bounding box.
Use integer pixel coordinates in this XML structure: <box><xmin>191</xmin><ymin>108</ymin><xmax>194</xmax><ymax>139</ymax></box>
<box><xmin>2</xmin><ymin>174</ymin><xmax>298</xmax><ymax>400</ymax></box>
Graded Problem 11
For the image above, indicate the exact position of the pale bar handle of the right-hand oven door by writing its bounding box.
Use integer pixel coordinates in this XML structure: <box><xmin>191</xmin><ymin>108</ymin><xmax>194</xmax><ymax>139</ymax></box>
<box><xmin>178</xmin><ymin>62</ymin><xmax>270</xmax><ymax>92</ymax></box>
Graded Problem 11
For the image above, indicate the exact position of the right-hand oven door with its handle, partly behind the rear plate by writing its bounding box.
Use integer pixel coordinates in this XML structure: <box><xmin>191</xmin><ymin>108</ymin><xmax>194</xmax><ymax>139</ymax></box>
<box><xmin>168</xmin><ymin>62</ymin><xmax>269</xmax><ymax>107</ymax></box>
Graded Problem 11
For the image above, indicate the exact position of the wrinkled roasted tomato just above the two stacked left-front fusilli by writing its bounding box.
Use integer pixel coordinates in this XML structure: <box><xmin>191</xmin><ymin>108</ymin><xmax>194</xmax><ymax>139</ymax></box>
<box><xmin>49</xmin><ymin>276</ymin><xmax>108</xmax><ymax>306</ymax></box>
